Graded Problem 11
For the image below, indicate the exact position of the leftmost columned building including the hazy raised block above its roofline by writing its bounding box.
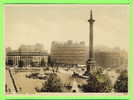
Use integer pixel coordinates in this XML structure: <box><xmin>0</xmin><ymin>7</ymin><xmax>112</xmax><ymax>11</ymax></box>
<box><xmin>6</xmin><ymin>44</ymin><xmax>48</xmax><ymax>66</ymax></box>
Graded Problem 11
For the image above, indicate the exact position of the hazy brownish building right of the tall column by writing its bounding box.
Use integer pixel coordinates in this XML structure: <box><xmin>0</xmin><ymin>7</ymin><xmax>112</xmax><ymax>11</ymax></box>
<box><xmin>95</xmin><ymin>51</ymin><xmax>128</xmax><ymax>68</ymax></box>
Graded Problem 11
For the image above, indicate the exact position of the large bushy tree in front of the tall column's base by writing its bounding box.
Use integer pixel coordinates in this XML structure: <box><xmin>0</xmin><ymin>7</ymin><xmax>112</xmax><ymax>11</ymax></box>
<box><xmin>82</xmin><ymin>70</ymin><xmax>112</xmax><ymax>93</ymax></box>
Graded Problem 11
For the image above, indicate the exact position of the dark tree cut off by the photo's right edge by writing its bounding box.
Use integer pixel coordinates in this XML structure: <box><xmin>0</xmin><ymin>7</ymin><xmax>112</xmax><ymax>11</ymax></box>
<box><xmin>114</xmin><ymin>71</ymin><xmax>128</xmax><ymax>92</ymax></box>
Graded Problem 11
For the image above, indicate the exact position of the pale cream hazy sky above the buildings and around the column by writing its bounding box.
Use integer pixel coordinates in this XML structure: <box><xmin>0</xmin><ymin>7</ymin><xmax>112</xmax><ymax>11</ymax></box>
<box><xmin>4</xmin><ymin>4</ymin><xmax>130</xmax><ymax>51</ymax></box>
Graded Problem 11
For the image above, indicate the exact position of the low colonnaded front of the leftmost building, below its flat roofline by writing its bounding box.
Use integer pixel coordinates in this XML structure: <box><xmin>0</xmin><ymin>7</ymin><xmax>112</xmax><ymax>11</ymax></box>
<box><xmin>6</xmin><ymin>51</ymin><xmax>48</xmax><ymax>67</ymax></box>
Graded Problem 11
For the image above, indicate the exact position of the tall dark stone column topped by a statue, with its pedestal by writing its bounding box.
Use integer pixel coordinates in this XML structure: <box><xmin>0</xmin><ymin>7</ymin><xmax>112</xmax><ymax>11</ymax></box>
<box><xmin>85</xmin><ymin>10</ymin><xmax>96</xmax><ymax>74</ymax></box>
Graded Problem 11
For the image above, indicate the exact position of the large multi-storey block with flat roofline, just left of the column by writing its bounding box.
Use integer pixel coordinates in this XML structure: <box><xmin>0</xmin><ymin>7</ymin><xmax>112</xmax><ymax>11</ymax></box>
<box><xmin>51</xmin><ymin>40</ymin><xmax>88</xmax><ymax>64</ymax></box>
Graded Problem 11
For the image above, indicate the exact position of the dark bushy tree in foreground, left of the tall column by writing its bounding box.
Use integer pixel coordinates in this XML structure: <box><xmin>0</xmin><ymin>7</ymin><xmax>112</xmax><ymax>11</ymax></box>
<box><xmin>40</xmin><ymin>73</ymin><xmax>63</xmax><ymax>92</ymax></box>
